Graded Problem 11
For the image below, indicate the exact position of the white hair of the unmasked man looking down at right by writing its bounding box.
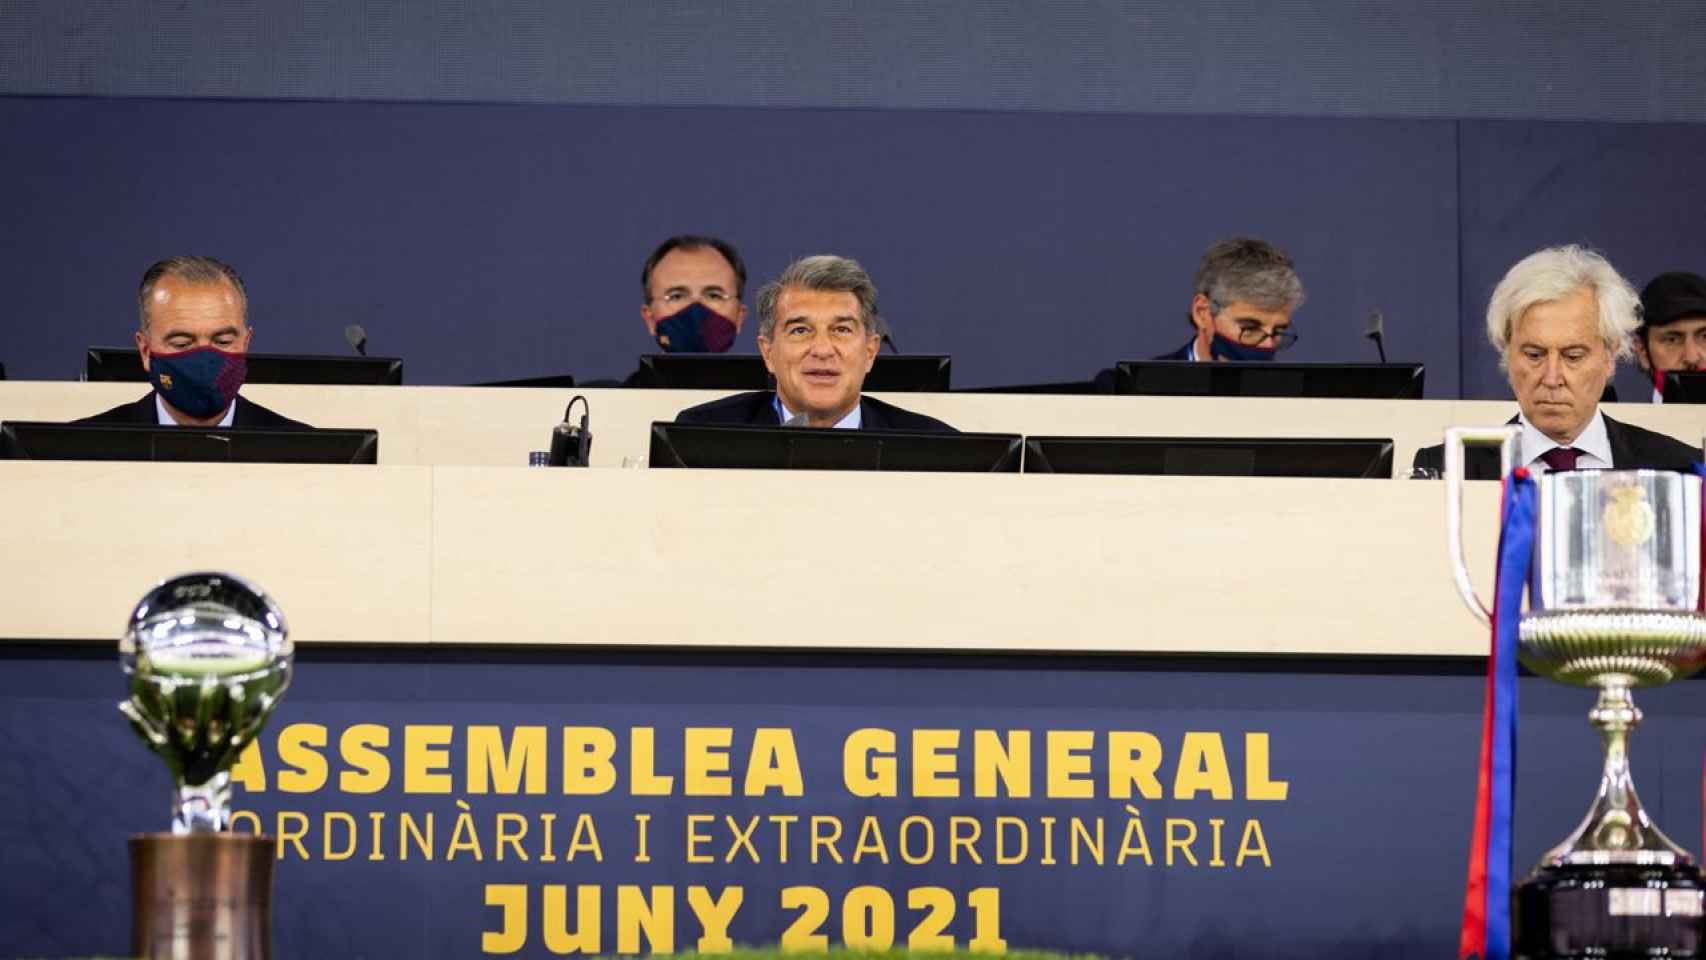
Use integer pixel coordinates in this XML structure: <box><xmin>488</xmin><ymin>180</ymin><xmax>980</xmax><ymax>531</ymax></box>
<box><xmin>1488</xmin><ymin>244</ymin><xmax>1641</xmax><ymax>370</ymax></box>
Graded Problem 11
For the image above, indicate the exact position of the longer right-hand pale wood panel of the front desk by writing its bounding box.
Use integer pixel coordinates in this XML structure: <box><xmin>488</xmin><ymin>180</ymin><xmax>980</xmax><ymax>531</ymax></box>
<box><xmin>433</xmin><ymin>469</ymin><xmax>1498</xmax><ymax>655</ymax></box>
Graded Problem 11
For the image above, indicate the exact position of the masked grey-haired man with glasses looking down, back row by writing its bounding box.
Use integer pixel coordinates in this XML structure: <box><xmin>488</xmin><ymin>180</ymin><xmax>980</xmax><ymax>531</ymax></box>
<box><xmin>1095</xmin><ymin>237</ymin><xmax>1305</xmax><ymax>394</ymax></box>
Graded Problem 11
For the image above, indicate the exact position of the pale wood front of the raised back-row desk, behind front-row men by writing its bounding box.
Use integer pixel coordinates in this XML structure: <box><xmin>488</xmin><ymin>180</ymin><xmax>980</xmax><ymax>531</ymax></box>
<box><xmin>0</xmin><ymin>382</ymin><xmax>1706</xmax><ymax>476</ymax></box>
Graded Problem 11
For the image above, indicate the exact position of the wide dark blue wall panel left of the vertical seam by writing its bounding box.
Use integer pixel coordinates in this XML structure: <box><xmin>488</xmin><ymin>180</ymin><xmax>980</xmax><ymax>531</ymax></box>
<box><xmin>0</xmin><ymin>99</ymin><xmax>1457</xmax><ymax>396</ymax></box>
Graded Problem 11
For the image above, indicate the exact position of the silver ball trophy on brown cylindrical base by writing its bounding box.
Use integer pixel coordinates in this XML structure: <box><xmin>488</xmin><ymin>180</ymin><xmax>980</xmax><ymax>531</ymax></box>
<box><xmin>118</xmin><ymin>573</ymin><xmax>292</xmax><ymax>958</ymax></box>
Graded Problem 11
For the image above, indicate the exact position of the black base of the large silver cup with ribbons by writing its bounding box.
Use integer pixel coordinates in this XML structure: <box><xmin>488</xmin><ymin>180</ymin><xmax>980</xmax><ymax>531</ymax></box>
<box><xmin>1512</xmin><ymin>863</ymin><xmax>1706</xmax><ymax>960</ymax></box>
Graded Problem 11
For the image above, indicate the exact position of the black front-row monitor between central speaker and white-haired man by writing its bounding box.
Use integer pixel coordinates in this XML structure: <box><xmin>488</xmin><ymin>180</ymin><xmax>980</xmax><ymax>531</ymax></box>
<box><xmin>1025</xmin><ymin>437</ymin><xmax>1392</xmax><ymax>479</ymax></box>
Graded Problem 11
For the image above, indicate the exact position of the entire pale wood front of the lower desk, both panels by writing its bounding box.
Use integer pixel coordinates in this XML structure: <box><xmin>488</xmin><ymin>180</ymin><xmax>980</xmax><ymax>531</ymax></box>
<box><xmin>0</xmin><ymin>462</ymin><xmax>1496</xmax><ymax>655</ymax></box>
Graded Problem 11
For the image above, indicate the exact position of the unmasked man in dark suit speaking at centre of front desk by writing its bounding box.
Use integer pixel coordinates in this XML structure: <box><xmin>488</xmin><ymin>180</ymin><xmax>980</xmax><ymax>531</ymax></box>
<box><xmin>676</xmin><ymin>256</ymin><xmax>955</xmax><ymax>433</ymax></box>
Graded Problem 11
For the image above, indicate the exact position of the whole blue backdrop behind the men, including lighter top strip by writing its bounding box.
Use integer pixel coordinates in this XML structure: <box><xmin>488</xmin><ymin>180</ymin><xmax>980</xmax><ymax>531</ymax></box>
<box><xmin>0</xmin><ymin>0</ymin><xmax>1706</xmax><ymax>397</ymax></box>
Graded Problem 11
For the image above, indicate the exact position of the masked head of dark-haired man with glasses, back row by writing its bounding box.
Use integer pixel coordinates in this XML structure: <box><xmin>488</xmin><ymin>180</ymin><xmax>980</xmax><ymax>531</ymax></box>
<box><xmin>640</xmin><ymin>234</ymin><xmax>746</xmax><ymax>353</ymax></box>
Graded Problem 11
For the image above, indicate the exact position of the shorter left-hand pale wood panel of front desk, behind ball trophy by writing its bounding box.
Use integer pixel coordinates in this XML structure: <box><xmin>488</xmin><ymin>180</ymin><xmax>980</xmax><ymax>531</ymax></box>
<box><xmin>0</xmin><ymin>462</ymin><xmax>432</xmax><ymax>643</ymax></box>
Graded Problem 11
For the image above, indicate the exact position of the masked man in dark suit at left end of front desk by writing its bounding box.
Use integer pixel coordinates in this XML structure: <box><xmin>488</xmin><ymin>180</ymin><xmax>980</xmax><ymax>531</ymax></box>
<box><xmin>77</xmin><ymin>257</ymin><xmax>309</xmax><ymax>430</ymax></box>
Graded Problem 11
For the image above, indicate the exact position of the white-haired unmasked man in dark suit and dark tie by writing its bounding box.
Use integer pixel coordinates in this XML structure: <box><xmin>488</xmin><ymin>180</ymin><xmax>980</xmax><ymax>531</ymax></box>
<box><xmin>1414</xmin><ymin>246</ymin><xmax>1701</xmax><ymax>479</ymax></box>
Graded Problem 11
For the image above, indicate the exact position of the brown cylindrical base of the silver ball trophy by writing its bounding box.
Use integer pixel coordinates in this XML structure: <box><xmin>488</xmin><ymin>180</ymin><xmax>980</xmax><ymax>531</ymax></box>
<box><xmin>130</xmin><ymin>834</ymin><xmax>273</xmax><ymax>960</ymax></box>
